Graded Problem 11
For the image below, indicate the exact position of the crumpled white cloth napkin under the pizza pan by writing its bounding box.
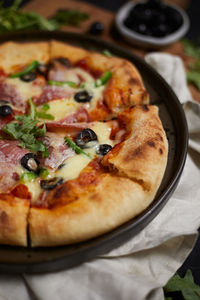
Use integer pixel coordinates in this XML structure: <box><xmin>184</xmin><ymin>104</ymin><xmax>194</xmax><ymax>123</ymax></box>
<box><xmin>0</xmin><ymin>53</ymin><xmax>200</xmax><ymax>300</ymax></box>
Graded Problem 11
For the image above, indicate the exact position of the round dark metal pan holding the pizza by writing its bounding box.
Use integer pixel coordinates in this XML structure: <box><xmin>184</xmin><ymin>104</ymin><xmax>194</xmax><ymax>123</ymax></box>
<box><xmin>0</xmin><ymin>32</ymin><xmax>188</xmax><ymax>273</ymax></box>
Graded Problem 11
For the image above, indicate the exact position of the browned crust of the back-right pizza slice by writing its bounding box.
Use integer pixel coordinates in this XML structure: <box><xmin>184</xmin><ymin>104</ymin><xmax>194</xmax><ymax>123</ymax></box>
<box><xmin>50</xmin><ymin>41</ymin><xmax>149</xmax><ymax>113</ymax></box>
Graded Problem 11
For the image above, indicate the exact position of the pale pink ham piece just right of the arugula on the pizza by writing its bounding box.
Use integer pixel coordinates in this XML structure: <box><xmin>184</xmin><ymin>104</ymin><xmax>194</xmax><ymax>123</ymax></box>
<box><xmin>39</xmin><ymin>132</ymin><xmax>75</xmax><ymax>170</ymax></box>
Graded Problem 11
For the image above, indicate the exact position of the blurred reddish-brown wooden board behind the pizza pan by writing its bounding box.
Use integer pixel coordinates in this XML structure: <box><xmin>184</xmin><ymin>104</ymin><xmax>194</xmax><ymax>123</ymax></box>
<box><xmin>24</xmin><ymin>0</ymin><xmax>200</xmax><ymax>103</ymax></box>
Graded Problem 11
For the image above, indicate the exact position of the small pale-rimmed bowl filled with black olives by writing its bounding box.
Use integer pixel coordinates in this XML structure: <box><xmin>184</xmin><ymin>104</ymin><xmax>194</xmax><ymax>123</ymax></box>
<box><xmin>115</xmin><ymin>0</ymin><xmax>190</xmax><ymax>49</ymax></box>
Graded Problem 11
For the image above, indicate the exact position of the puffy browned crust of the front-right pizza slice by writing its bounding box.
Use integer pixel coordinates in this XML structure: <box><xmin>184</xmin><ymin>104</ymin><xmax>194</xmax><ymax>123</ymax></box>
<box><xmin>29</xmin><ymin>106</ymin><xmax>168</xmax><ymax>247</ymax></box>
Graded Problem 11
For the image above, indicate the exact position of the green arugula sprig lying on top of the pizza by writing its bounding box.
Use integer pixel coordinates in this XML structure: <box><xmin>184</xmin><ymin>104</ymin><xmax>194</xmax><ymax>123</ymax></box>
<box><xmin>3</xmin><ymin>99</ymin><xmax>49</xmax><ymax>157</ymax></box>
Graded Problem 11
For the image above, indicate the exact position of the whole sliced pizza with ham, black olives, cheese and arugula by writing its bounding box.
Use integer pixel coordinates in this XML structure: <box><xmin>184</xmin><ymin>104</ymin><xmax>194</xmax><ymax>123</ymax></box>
<box><xmin>0</xmin><ymin>40</ymin><xmax>168</xmax><ymax>247</ymax></box>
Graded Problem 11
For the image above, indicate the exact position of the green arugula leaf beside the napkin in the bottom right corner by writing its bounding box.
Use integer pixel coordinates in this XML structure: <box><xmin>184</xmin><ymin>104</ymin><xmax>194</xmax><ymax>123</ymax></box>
<box><xmin>164</xmin><ymin>270</ymin><xmax>200</xmax><ymax>300</ymax></box>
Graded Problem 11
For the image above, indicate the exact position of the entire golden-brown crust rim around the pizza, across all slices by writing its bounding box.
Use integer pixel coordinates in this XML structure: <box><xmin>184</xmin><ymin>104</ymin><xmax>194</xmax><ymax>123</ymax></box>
<box><xmin>0</xmin><ymin>41</ymin><xmax>168</xmax><ymax>247</ymax></box>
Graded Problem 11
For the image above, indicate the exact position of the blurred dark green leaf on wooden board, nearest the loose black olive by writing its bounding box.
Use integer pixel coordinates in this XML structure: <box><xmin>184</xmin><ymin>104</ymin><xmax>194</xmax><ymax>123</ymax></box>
<box><xmin>51</xmin><ymin>9</ymin><xmax>89</xmax><ymax>26</ymax></box>
